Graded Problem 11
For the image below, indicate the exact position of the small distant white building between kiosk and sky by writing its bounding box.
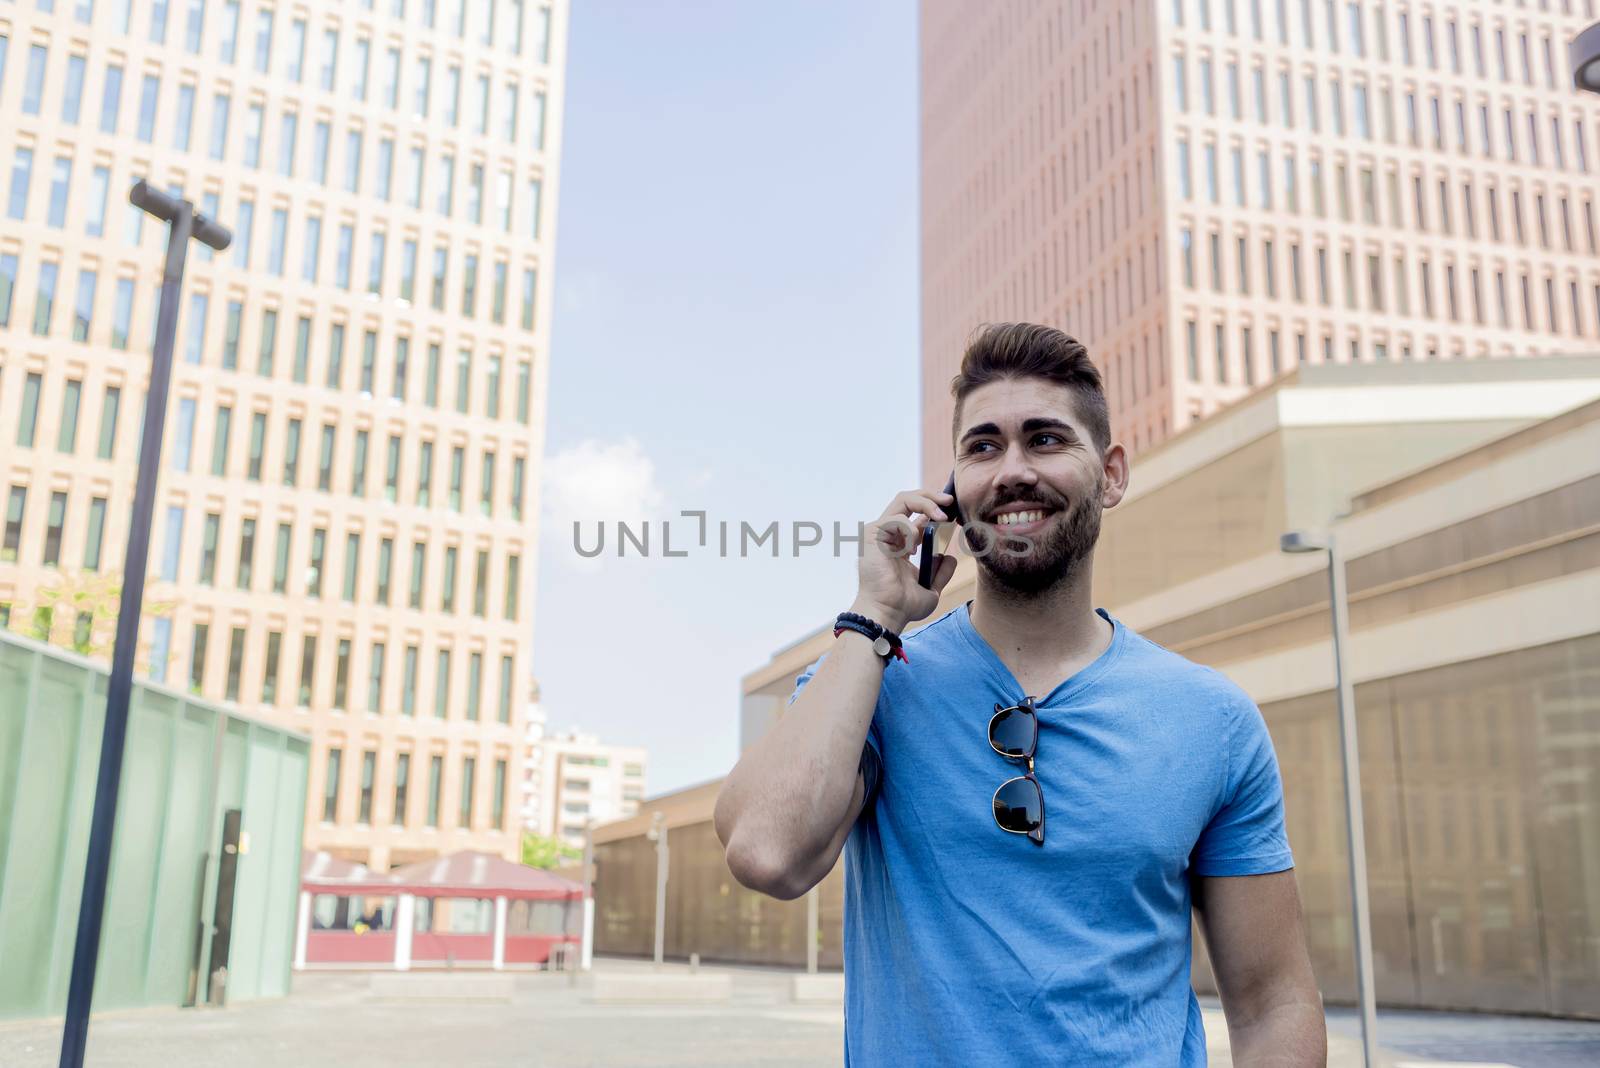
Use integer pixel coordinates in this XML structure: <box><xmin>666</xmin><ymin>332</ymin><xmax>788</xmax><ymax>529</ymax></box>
<box><xmin>520</xmin><ymin>702</ymin><xmax>650</xmax><ymax>849</ymax></box>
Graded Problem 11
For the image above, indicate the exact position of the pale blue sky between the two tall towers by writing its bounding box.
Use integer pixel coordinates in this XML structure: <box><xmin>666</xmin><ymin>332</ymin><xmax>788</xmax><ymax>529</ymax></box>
<box><xmin>533</xmin><ymin>0</ymin><xmax>918</xmax><ymax>796</ymax></box>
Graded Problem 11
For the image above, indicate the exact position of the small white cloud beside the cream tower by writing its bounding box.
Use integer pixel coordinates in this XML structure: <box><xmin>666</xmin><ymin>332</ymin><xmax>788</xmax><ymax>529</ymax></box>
<box><xmin>542</xmin><ymin>436</ymin><xmax>666</xmax><ymax>571</ymax></box>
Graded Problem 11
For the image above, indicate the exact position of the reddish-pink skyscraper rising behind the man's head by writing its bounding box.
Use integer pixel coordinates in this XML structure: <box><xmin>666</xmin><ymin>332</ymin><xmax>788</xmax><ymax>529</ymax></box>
<box><xmin>922</xmin><ymin>0</ymin><xmax>1600</xmax><ymax>484</ymax></box>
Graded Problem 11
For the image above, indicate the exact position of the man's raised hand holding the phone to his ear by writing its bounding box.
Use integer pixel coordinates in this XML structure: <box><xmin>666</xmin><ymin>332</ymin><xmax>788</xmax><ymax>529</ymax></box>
<box><xmin>851</xmin><ymin>489</ymin><xmax>955</xmax><ymax>633</ymax></box>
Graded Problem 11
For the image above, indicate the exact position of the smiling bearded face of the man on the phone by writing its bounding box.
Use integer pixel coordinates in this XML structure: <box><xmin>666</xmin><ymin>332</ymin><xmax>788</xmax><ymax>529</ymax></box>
<box><xmin>955</xmin><ymin>377</ymin><xmax>1128</xmax><ymax>596</ymax></box>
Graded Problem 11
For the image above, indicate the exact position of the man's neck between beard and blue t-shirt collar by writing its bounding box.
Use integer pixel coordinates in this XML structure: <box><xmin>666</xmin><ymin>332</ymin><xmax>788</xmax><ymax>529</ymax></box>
<box><xmin>968</xmin><ymin>556</ymin><xmax>1112</xmax><ymax>676</ymax></box>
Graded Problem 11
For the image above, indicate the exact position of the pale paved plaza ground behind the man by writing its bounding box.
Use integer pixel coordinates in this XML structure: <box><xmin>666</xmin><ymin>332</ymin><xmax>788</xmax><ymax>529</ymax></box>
<box><xmin>0</xmin><ymin>961</ymin><xmax>1600</xmax><ymax>1068</ymax></box>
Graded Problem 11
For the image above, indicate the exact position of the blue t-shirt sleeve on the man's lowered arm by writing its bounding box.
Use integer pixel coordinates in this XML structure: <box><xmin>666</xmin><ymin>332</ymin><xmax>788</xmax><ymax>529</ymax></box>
<box><xmin>1190</xmin><ymin>697</ymin><xmax>1294</xmax><ymax>876</ymax></box>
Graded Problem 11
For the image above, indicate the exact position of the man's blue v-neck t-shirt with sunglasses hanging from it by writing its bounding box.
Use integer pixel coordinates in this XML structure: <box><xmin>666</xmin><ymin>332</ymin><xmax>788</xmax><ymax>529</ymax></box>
<box><xmin>789</xmin><ymin>604</ymin><xmax>1293</xmax><ymax>1068</ymax></box>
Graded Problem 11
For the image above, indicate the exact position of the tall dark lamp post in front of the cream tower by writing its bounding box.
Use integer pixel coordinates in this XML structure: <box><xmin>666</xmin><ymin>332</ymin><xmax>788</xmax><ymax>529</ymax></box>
<box><xmin>59</xmin><ymin>179</ymin><xmax>234</xmax><ymax>1068</ymax></box>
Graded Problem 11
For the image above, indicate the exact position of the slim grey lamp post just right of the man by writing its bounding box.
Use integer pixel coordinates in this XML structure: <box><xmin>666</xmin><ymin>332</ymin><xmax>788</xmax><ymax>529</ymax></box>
<box><xmin>1278</xmin><ymin>531</ymin><xmax>1378</xmax><ymax>1068</ymax></box>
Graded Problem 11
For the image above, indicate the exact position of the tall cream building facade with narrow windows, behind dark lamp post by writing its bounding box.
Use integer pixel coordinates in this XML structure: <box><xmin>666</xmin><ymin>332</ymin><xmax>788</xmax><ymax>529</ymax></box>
<box><xmin>0</xmin><ymin>0</ymin><xmax>566</xmax><ymax>870</ymax></box>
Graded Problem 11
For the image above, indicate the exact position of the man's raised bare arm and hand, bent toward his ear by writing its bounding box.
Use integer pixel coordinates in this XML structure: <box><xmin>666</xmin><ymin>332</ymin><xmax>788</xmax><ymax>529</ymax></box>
<box><xmin>714</xmin><ymin>491</ymin><xmax>955</xmax><ymax>899</ymax></box>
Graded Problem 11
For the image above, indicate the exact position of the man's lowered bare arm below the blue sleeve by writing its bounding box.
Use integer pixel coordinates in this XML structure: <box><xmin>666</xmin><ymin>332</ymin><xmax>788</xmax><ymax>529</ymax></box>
<box><xmin>1195</xmin><ymin>870</ymin><xmax>1328</xmax><ymax>1068</ymax></box>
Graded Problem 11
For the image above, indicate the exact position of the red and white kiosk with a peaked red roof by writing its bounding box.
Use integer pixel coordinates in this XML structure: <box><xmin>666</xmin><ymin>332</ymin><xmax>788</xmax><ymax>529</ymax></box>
<box><xmin>294</xmin><ymin>851</ymin><xmax>584</xmax><ymax>972</ymax></box>
